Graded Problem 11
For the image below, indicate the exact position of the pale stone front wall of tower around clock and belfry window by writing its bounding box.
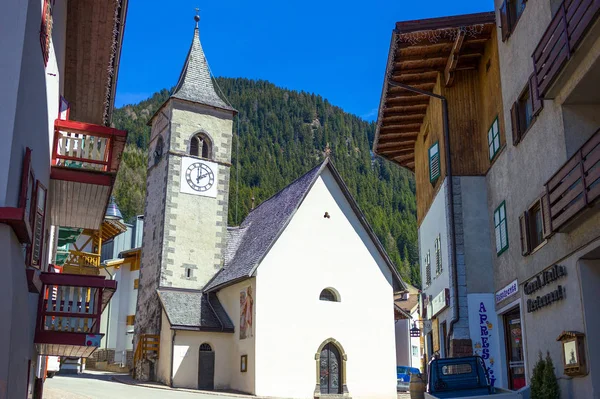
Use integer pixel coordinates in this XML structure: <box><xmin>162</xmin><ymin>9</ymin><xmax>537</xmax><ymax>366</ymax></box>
<box><xmin>161</xmin><ymin>101</ymin><xmax>233</xmax><ymax>289</ymax></box>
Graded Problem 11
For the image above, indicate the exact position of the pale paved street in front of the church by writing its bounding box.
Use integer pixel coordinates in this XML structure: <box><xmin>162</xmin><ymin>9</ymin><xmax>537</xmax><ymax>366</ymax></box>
<box><xmin>44</xmin><ymin>371</ymin><xmax>410</xmax><ymax>399</ymax></box>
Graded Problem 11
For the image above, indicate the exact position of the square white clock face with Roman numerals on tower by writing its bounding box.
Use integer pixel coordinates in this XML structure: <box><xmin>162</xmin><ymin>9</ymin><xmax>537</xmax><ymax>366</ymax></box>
<box><xmin>179</xmin><ymin>157</ymin><xmax>218</xmax><ymax>198</ymax></box>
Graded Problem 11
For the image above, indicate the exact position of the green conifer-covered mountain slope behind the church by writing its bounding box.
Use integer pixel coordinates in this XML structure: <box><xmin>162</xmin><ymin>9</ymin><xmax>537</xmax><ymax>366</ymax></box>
<box><xmin>113</xmin><ymin>78</ymin><xmax>420</xmax><ymax>286</ymax></box>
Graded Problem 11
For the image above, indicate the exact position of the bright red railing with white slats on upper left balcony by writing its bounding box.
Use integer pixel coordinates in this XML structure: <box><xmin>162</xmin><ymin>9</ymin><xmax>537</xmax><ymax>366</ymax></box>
<box><xmin>52</xmin><ymin>119</ymin><xmax>127</xmax><ymax>173</ymax></box>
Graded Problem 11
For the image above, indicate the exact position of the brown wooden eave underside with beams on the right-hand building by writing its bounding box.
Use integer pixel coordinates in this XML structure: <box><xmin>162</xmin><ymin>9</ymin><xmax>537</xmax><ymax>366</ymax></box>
<box><xmin>373</xmin><ymin>12</ymin><xmax>496</xmax><ymax>171</ymax></box>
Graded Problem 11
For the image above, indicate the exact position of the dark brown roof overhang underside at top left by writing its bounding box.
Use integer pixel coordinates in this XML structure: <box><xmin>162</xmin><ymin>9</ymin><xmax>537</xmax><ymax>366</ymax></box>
<box><xmin>64</xmin><ymin>0</ymin><xmax>128</xmax><ymax>125</ymax></box>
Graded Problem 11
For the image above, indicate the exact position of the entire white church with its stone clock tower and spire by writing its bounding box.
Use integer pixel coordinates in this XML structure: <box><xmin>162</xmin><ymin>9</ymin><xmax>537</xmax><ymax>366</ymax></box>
<box><xmin>135</xmin><ymin>16</ymin><xmax>405</xmax><ymax>399</ymax></box>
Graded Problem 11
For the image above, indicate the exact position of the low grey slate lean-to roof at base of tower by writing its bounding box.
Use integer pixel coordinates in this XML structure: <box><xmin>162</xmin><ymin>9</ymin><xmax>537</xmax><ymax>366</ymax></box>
<box><xmin>157</xmin><ymin>288</ymin><xmax>234</xmax><ymax>332</ymax></box>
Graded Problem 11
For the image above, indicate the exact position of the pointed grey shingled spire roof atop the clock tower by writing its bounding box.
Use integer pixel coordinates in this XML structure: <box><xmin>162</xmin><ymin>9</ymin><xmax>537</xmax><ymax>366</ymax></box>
<box><xmin>171</xmin><ymin>15</ymin><xmax>235</xmax><ymax>112</ymax></box>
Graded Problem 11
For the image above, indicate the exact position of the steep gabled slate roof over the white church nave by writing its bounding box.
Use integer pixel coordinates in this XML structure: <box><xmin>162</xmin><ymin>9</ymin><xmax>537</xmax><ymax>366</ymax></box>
<box><xmin>204</xmin><ymin>158</ymin><xmax>405</xmax><ymax>292</ymax></box>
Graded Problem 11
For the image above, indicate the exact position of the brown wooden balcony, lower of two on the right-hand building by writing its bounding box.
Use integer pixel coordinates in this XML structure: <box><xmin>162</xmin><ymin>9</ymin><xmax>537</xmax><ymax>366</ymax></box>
<box><xmin>546</xmin><ymin>129</ymin><xmax>600</xmax><ymax>232</ymax></box>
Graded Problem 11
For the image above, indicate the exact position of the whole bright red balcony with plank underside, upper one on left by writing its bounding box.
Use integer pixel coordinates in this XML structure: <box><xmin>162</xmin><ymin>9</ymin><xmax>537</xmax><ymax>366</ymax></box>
<box><xmin>50</xmin><ymin>119</ymin><xmax>127</xmax><ymax>230</ymax></box>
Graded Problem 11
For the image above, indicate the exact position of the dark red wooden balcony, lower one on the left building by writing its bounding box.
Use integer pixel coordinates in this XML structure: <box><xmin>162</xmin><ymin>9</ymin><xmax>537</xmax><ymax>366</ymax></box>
<box><xmin>34</xmin><ymin>273</ymin><xmax>117</xmax><ymax>357</ymax></box>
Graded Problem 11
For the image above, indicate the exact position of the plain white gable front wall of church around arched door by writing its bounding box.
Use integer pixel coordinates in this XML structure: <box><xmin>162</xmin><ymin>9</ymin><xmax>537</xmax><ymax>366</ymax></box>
<box><xmin>256</xmin><ymin>170</ymin><xmax>396</xmax><ymax>399</ymax></box>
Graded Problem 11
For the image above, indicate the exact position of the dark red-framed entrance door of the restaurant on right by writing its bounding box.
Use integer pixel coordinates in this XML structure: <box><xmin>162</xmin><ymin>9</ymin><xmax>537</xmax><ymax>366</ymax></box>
<box><xmin>504</xmin><ymin>308</ymin><xmax>525</xmax><ymax>390</ymax></box>
